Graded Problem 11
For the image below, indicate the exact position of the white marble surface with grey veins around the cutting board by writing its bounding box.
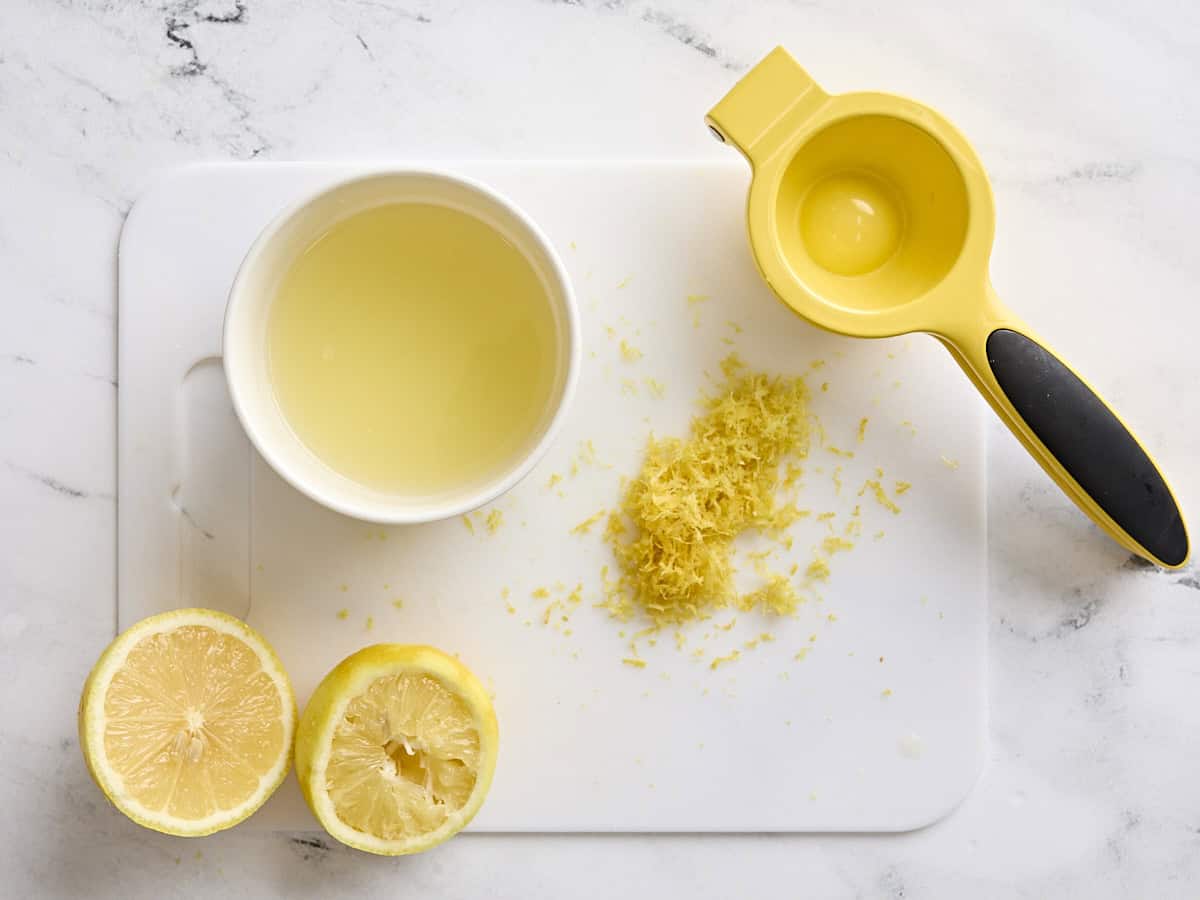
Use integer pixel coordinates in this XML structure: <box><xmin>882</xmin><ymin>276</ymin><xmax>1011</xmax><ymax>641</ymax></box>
<box><xmin>0</xmin><ymin>0</ymin><xmax>1200</xmax><ymax>898</ymax></box>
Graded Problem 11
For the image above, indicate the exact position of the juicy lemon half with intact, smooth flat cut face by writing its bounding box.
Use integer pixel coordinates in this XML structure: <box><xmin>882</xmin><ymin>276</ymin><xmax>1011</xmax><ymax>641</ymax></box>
<box><xmin>79</xmin><ymin>610</ymin><xmax>296</xmax><ymax>836</ymax></box>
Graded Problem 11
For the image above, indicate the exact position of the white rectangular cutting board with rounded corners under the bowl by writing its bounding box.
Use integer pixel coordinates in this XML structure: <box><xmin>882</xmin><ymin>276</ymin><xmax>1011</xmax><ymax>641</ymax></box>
<box><xmin>118</xmin><ymin>160</ymin><xmax>986</xmax><ymax>832</ymax></box>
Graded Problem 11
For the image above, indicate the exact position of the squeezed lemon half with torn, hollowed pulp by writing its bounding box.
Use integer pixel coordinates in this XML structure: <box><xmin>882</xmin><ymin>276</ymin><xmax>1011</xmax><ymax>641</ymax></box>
<box><xmin>295</xmin><ymin>644</ymin><xmax>498</xmax><ymax>856</ymax></box>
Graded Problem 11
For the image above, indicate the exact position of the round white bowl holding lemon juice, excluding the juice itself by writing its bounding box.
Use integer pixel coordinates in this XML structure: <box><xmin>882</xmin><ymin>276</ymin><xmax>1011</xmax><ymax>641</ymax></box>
<box><xmin>223</xmin><ymin>169</ymin><xmax>580</xmax><ymax>523</ymax></box>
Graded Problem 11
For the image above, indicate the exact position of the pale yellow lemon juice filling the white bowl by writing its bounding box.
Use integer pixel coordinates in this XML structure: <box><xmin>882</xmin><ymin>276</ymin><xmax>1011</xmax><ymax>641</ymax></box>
<box><xmin>268</xmin><ymin>203</ymin><xmax>558</xmax><ymax>494</ymax></box>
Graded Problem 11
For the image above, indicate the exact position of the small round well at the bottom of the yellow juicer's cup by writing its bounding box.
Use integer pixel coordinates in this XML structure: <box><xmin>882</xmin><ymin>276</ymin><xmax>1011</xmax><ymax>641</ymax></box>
<box><xmin>800</xmin><ymin>173</ymin><xmax>904</xmax><ymax>275</ymax></box>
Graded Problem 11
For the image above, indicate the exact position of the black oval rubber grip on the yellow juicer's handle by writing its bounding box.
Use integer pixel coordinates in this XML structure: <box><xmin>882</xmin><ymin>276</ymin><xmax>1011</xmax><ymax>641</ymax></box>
<box><xmin>988</xmin><ymin>329</ymin><xmax>1188</xmax><ymax>565</ymax></box>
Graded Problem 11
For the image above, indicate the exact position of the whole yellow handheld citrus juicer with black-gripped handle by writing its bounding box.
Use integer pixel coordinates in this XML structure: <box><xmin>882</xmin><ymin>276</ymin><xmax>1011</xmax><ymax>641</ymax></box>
<box><xmin>707</xmin><ymin>48</ymin><xmax>1189</xmax><ymax>569</ymax></box>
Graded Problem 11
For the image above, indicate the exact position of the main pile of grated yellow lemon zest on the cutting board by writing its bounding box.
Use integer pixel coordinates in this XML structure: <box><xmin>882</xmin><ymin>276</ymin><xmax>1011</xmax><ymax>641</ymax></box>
<box><xmin>602</xmin><ymin>362</ymin><xmax>809</xmax><ymax>626</ymax></box>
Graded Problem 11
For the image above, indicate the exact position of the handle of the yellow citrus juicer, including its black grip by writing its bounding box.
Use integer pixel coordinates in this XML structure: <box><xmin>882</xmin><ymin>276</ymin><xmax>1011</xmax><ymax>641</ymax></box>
<box><xmin>943</xmin><ymin>303</ymin><xmax>1189</xmax><ymax>569</ymax></box>
